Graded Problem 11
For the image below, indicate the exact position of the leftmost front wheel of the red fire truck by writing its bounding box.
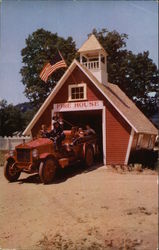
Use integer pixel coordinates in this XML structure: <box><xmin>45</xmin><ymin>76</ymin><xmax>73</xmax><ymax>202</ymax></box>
<box><xmin>4</xmin><ymin>160</ymin><xmax>21</xmax><ymax>182</ymax></box>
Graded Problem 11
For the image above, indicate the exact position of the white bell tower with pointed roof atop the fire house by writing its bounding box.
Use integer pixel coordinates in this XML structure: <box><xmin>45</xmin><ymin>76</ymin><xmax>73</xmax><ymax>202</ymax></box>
<box><xmin>78</xmin><ymin>34</ymin><xmax>108</xmax><ymax>85</ymax></box>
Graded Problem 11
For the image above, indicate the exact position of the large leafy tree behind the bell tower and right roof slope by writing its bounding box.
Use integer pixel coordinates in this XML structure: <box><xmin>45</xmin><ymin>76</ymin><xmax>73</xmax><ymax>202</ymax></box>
<box><xmin>92</xmin><ymin>29</ymin><xmax>159</xmax><ymax>117</ymax></box>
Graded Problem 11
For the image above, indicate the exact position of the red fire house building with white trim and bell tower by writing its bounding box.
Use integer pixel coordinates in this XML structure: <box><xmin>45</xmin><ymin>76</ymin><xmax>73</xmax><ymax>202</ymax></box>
<box><xmin>24</xmin><ymin>35</ymin><xmax>158</xmax><ymax>164</ymax></box>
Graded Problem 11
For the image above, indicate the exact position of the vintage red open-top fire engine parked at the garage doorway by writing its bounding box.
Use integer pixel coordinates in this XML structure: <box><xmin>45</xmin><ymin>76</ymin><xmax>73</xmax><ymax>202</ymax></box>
<box><xmin>4</xmin><ymin>131</ymin><xmax>99</xmax><ymax>184</ymax></box>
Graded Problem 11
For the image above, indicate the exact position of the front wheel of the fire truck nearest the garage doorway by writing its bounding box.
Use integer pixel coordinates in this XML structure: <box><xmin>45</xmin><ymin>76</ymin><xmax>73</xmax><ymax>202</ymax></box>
<box><xmin>39</xmin><ymin>158</ymin><xmax>56</xmax><ymax>184</ymax></box>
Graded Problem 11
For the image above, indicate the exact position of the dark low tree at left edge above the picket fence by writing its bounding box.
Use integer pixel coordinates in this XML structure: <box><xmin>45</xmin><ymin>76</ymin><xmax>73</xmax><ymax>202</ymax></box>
<box><xmin>0</xmin><ymin>100</ymin><xmax>24</xmax><ymax>136</ymax></box>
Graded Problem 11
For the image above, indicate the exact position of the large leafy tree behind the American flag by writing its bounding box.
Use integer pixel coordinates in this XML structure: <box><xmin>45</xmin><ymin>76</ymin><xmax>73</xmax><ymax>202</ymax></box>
<box><xmin>20</xmin><ymin>29</ymin><xmax>76</xmax><ymax>108</ymax></box>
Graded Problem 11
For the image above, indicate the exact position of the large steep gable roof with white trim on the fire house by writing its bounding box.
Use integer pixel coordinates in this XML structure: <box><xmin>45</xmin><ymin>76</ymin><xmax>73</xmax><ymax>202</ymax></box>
<box><xmin>24</xmin><ymin>60</ymin><xmax>158</xmax><ymax>135</ymax></box>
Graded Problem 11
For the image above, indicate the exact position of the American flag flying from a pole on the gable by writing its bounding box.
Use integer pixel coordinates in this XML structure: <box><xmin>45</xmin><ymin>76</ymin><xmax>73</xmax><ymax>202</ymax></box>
<box><xmin>40</xmin><ymin>51</ymin><xmax>67</xmax><ymax>82</ymax></box>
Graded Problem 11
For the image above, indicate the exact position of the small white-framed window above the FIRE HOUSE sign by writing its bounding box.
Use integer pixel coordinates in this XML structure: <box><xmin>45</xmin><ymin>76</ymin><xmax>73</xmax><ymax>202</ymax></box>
<box><xmin>68</xmin><ymin>83</ymin><xmax>86</xmax><ymax>101</ymax></box>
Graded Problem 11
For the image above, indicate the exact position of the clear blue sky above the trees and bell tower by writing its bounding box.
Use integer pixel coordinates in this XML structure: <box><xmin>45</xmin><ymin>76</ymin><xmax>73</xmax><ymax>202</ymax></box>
<box><xmin>0</xmin><ymin>0</ymin><xmax>158</xmax><ymax>104</ymax></box>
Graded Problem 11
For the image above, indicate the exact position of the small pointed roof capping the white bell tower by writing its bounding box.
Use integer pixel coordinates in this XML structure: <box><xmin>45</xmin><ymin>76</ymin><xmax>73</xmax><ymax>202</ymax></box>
<box><xmin>78</xmin><ymin>34</ymin><xmax>107</xmax><ymax>54</ymax></box>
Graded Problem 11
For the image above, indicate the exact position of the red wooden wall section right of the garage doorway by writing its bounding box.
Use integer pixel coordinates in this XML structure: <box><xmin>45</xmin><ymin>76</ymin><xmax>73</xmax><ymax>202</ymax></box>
<box><xmin>106</xmin><ymin>100</ymin><xmax>131</xmax><ymax>164</ymax></box>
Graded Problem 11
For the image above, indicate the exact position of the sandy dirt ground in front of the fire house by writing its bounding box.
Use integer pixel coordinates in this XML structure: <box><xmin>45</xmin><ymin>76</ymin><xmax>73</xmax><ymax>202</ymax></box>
<box><xmin>0</xmin><ymin>166</ymin><xmax>158</xmax><ymax>250</ymax></box>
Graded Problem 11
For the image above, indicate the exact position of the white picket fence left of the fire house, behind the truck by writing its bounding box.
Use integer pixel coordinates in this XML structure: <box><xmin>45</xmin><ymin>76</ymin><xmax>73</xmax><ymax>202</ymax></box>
<box><xmin>0</xmin><ymin>136</ymin><xmax>31</xmax><ymax>150</ymax></box>
